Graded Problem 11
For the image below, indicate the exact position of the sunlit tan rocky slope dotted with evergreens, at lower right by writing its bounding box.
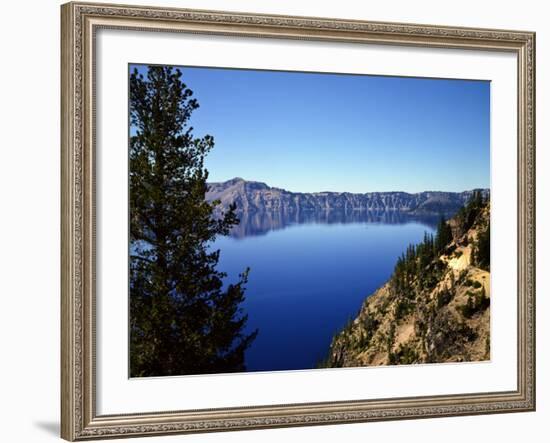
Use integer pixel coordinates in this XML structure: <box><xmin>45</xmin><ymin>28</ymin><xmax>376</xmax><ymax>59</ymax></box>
<box><xmin>322</xmin><ymin>199</ymin><xmax>491</xmax><ymax>367</ymax></box>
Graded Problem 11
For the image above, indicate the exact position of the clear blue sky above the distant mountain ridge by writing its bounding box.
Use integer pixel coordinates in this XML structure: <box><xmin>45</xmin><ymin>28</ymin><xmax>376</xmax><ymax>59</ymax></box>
<box><xmin>131</xmin><ymin>66</ymin><xmax>490</xmax><ymax>192</ymax></box>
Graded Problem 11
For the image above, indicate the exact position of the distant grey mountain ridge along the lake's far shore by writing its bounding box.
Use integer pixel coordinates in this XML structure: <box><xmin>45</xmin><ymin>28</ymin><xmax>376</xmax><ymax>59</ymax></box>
<box><xmin>206</xmin><ymin>177</ymin><xmax>489</xmax><ymax>214</ymax></box>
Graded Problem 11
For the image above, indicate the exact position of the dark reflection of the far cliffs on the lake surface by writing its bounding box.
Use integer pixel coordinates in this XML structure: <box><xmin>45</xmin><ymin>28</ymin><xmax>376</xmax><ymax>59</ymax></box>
<box><xmin>231</xmin><ymin>210</ymin><xmax>452</xmax><ymax>238</ymax></box>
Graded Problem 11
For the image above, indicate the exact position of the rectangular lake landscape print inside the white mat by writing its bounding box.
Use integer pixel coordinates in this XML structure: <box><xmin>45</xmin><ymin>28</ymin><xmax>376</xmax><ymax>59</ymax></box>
<box><xmin>128</xmin><ymin>64</ymin><xmax>491</xmax><ymax>377</ymax></box>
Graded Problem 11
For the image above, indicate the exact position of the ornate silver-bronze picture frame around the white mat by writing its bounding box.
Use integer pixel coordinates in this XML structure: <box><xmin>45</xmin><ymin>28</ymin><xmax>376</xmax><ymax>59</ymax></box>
<box><xmin>61</xmin><ymin>3</ymin><xmax>535</xmax><ymax>441</ymax></box>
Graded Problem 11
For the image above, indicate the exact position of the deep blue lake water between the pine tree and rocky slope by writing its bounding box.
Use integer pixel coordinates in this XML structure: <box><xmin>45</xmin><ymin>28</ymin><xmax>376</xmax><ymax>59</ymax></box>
<box><xmin>214</xmin><ymin>213</ymin><xmax>437</xmax><ymax>371</ymax></box>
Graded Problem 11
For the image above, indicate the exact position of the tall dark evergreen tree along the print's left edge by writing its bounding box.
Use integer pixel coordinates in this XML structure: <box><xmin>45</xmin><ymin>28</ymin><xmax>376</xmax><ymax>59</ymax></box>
<box><xmin>129</xmin><ymin>66</ymin><xmax>256</xmax><ymax>377</ymax></box>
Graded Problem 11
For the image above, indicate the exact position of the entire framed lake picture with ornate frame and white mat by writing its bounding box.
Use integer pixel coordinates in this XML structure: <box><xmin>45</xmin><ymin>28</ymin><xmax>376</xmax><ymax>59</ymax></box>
<box><xmin>61</xmin><ymin>2</ymin><xmax>535</xmax><ymax>441</ymax></box>
